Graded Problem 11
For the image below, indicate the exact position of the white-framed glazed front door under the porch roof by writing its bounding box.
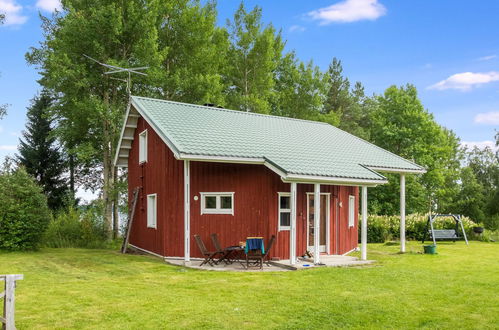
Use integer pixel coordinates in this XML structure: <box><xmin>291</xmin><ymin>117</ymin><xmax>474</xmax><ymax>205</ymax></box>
<box><xmin>307</xmin><ymin>193</ymin><xmax>330</xmax><ymax>252</ymax></box>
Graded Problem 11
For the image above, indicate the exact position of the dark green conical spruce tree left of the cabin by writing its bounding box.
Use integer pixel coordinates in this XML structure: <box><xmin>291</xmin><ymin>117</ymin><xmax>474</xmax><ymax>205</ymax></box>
<box><xmin>17</xmin><ymin>92</ymin><xmax>68</xmax><ymax>210</ymax></box>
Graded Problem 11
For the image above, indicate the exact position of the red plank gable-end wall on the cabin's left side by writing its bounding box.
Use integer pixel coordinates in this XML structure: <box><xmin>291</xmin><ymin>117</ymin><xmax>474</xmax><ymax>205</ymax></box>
<box><xmin>128</xmin><ymin>118</ymin><xmax>184</xmax><ymax>256</ymax></box>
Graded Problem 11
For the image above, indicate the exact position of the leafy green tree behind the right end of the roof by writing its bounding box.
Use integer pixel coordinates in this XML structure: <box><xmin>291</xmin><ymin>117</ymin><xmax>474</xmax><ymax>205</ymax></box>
<box><xmin>370</xmin><ymin>85</ymin><xmax>460</xmax><ymax>214</ymax></box>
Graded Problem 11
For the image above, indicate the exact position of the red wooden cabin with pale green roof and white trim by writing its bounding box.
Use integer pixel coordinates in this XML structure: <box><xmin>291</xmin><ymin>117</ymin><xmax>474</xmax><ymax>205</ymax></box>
<box><xmin>115</xmin><ymin>96</ymin><xmax>424</xmax><ymax>263</ymax></box>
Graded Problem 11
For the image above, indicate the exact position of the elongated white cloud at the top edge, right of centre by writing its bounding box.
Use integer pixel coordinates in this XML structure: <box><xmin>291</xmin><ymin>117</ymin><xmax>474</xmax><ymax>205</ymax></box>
<box><xmin>307</xmin><ymin>0</ymin><xmax>386</xmax><ymax>25</ymax></box>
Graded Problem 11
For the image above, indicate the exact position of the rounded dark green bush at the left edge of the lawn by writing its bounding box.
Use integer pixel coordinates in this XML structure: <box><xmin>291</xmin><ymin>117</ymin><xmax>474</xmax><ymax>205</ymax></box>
<box><xmin>0</xmin><ymin>166</ymin><xmax>50</xmax><ymax>250</ymax></box>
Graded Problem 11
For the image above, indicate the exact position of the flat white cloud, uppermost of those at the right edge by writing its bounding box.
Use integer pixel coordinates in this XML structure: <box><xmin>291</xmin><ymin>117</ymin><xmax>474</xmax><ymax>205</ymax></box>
<box><xmin>428</xmin><ymin>71</ymin><xmax>499</xmax><ymax>91</ymax></box>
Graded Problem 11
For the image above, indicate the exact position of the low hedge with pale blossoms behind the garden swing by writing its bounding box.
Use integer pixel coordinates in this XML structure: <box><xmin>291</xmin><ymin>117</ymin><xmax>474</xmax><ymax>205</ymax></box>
<box><xmin>359</xmin><ymin>213</ymin><xmax>476</xmax><ymax>243</ymax></box>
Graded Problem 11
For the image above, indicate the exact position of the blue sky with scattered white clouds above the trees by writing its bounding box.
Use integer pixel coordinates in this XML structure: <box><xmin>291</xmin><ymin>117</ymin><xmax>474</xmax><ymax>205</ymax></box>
<box><xmin>0</xmin><ymin>0</ymin><xmax>499</xmax><ymax>164</ymax></box>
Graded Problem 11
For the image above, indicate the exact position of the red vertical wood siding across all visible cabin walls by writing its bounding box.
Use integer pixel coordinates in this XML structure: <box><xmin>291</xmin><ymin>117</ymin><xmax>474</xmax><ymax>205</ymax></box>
<box><xmin>128</xmin><ymin>112</ymin><xmax>358</xmax><ymax>259</ymax></box>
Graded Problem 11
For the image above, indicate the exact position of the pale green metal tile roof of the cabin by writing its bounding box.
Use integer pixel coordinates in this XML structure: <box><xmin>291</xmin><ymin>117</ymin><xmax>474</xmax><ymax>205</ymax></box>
<box><xmin>126</xmin><ymin>96</ymin><xmax>424</xmax><ymax>183</ymax></box>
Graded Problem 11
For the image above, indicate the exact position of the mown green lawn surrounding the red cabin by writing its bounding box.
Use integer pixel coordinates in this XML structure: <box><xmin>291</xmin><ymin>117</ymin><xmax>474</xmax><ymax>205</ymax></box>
<box><xmin>0</xmin><ymin>242</ymin><xmax>499</xmax><ymax>329</ymax></box>
